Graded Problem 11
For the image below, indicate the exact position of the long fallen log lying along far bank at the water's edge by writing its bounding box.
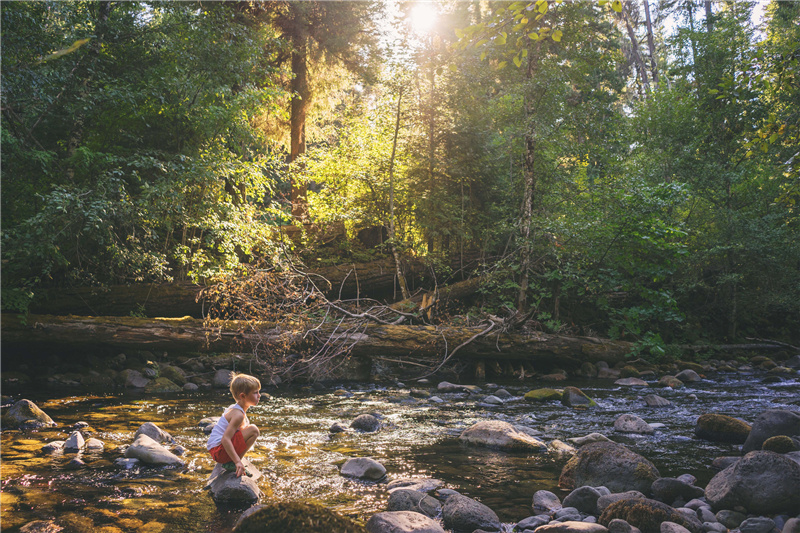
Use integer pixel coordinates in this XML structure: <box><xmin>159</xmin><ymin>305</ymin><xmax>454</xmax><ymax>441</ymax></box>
<box><xmin>1</xmin><ymin>314</ymin><xmax>632</xmax><ymax>367</ymax></box>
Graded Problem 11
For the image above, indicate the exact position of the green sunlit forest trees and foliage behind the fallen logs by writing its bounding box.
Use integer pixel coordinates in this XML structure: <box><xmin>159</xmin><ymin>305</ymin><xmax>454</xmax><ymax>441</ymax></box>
<box><xmin>0</xmin><ymin>0</ymin><xmax>800</xmax><ymax>353</ymax></box>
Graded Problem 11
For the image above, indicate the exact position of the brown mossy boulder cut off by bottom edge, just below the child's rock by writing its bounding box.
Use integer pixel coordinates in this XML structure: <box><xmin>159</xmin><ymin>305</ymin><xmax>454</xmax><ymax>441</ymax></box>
<box><xmin>233</xmin><ymin>502</ymin><xmax>366</xmax><ymax>533</ymax></box>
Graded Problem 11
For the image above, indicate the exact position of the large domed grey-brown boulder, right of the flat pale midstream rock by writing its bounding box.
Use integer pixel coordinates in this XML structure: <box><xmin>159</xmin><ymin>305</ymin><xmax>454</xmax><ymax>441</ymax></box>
<box><xmin>558</xmin><ymin>442</ymin><xmax>661</xmax><ymax>492</ymax></box>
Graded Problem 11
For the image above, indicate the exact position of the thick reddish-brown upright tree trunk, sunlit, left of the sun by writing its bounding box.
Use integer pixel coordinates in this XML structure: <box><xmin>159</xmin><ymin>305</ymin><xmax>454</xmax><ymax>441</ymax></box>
<box><xmin>289</xmin><ymin>37</ymin><xmax>311</xmax><ymax>221</ymax></box>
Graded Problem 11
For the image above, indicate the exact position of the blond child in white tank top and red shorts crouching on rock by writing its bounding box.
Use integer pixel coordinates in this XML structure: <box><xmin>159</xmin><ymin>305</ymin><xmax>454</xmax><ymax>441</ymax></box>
<box><xmin>206</xmin><ymin>374</ymin><xmax>261</xmax><ymax>477</ymax></box>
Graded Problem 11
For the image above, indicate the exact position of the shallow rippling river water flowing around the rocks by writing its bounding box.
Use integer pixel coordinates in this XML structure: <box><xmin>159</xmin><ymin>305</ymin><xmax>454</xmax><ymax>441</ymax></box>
<box><xmin>0</xmin><ymin>374</ymin><xmax>800</xmax><ymax>533</ymax></box>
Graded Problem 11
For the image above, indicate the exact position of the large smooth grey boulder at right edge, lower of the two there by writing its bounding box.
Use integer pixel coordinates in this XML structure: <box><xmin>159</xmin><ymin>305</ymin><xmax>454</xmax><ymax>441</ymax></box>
<box><xmin>705</xmin><ymin>451</ymin><xmax>800</xmax><ymax>514</ymax></box>
